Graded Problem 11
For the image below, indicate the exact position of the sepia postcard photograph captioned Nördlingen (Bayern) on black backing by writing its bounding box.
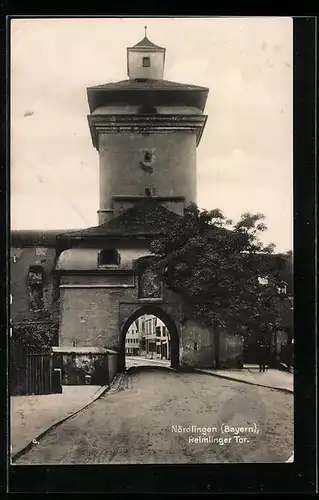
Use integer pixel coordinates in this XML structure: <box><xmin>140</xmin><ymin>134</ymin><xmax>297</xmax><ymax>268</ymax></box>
<box><xmin>9</xmin><ymin>17</ymin><xmax>294</xmax><ymax>469</ymax></box>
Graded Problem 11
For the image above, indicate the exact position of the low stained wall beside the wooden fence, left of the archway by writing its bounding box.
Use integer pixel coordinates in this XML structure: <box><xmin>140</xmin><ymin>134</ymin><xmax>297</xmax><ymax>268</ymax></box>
<box><xmin>53</xmin><ymin>347</ymin><xmax>117</xmax><ymax>385</ymax></box>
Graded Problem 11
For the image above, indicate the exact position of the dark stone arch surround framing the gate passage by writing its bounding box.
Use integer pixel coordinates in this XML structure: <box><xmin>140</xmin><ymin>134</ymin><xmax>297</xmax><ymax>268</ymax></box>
<box><xmin>118</xmin><ymin>304</ymin><xmax>180</xmax><ymax>372</ymax></box>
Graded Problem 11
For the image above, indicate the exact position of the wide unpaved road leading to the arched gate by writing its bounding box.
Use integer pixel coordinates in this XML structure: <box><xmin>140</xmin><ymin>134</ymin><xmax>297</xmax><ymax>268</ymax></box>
<box><xmin>16</xmin><ymin>367</ymin><xmax>293</xmax><ymax>465</ymax></box>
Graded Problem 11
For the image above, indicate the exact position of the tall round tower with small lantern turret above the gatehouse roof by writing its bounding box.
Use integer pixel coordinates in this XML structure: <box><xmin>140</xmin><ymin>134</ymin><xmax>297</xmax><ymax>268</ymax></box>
<box><xmin>87</xmin><ymin>27</ymin><xmax>208</xmax><ymax>224</ymax></box>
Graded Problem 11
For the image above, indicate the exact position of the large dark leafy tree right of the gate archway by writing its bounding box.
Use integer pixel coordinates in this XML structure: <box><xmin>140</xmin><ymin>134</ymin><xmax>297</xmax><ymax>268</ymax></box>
<box><xmin>150</xmin><ymin>204</ymin><xmax>292</xmax><ymax>368</ymax></box>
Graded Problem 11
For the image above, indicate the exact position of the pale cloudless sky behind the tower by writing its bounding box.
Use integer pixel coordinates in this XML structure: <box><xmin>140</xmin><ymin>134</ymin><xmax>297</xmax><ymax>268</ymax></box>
<box><xmin>11</xmin><ymin>17</ymin><xmax>293</xmax><ymax>252</ymax></box>
